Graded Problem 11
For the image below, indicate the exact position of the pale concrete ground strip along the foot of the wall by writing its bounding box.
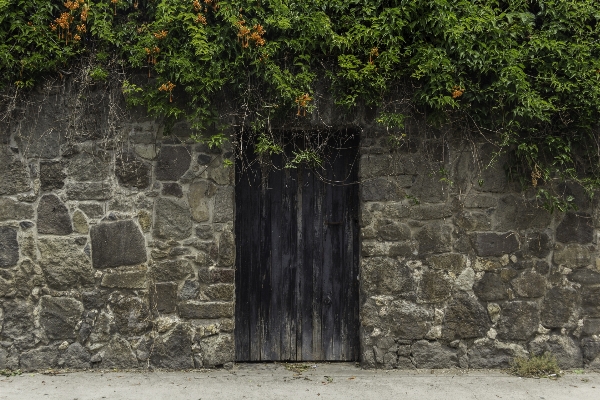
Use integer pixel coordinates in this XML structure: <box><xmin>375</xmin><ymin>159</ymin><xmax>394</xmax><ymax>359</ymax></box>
<box><xmin>0</xmin><ymin>363</ymin><xmax>600</xmax><ymax>400</ymax></box>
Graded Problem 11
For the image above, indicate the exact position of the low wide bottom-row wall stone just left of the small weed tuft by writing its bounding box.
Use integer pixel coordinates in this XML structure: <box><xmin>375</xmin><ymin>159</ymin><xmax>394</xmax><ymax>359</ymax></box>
<box><xmin>468</xmin><ymin>339</ymin><xmax>528</xmax><ymax>369</ymax></box>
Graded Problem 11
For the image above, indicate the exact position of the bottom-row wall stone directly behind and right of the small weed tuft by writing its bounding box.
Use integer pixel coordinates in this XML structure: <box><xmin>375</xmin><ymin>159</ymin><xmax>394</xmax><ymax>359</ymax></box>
<box><xmin>529</xmin><ymin>335</ymin><xmax>583</xmax><ymax>369</ymax></box>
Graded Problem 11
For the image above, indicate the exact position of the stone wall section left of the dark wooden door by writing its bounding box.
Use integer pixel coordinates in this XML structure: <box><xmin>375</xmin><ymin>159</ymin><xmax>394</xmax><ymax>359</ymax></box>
<box><xmin>0</xmin><ymin>85</ymin><xmax>235</xmax><ymax>370</ymax></box>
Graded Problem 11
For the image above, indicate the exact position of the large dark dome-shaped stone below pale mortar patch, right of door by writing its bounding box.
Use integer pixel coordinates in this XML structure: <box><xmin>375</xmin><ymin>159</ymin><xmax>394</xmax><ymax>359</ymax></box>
<box><xmin>442</xmin><ymin>292</ymin><xmax>491</xmax><ymax>340</ymax></box>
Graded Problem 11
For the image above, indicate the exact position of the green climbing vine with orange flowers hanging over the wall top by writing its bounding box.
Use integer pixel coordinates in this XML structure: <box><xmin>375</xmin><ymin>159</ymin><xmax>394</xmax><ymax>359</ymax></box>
<box><xmin>0</xmin><ymin>0</ymin><xmax>600</xmax><ymax>203</ymax></box>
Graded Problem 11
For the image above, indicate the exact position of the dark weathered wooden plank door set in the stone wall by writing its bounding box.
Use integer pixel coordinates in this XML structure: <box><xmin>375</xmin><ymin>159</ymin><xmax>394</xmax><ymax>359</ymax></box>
<box><xmin>235</xmin><ymin>133</ymin><xmax>360</xmax><ymax>361</ymax></box>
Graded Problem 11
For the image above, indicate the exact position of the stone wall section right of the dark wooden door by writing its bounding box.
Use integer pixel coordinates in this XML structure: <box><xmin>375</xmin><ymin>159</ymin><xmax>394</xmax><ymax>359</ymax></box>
<box><xmin>360</xmin><ymin>128</ymin><xmax>600</xmax><ymax>368</ymax></box>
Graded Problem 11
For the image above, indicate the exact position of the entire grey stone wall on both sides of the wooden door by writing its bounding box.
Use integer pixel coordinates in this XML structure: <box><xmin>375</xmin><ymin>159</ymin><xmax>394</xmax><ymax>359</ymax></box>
<box><xmin>0</xmin><ymin>84</ymin><xmax>600</xmax><ymax>370</ymax></box>
